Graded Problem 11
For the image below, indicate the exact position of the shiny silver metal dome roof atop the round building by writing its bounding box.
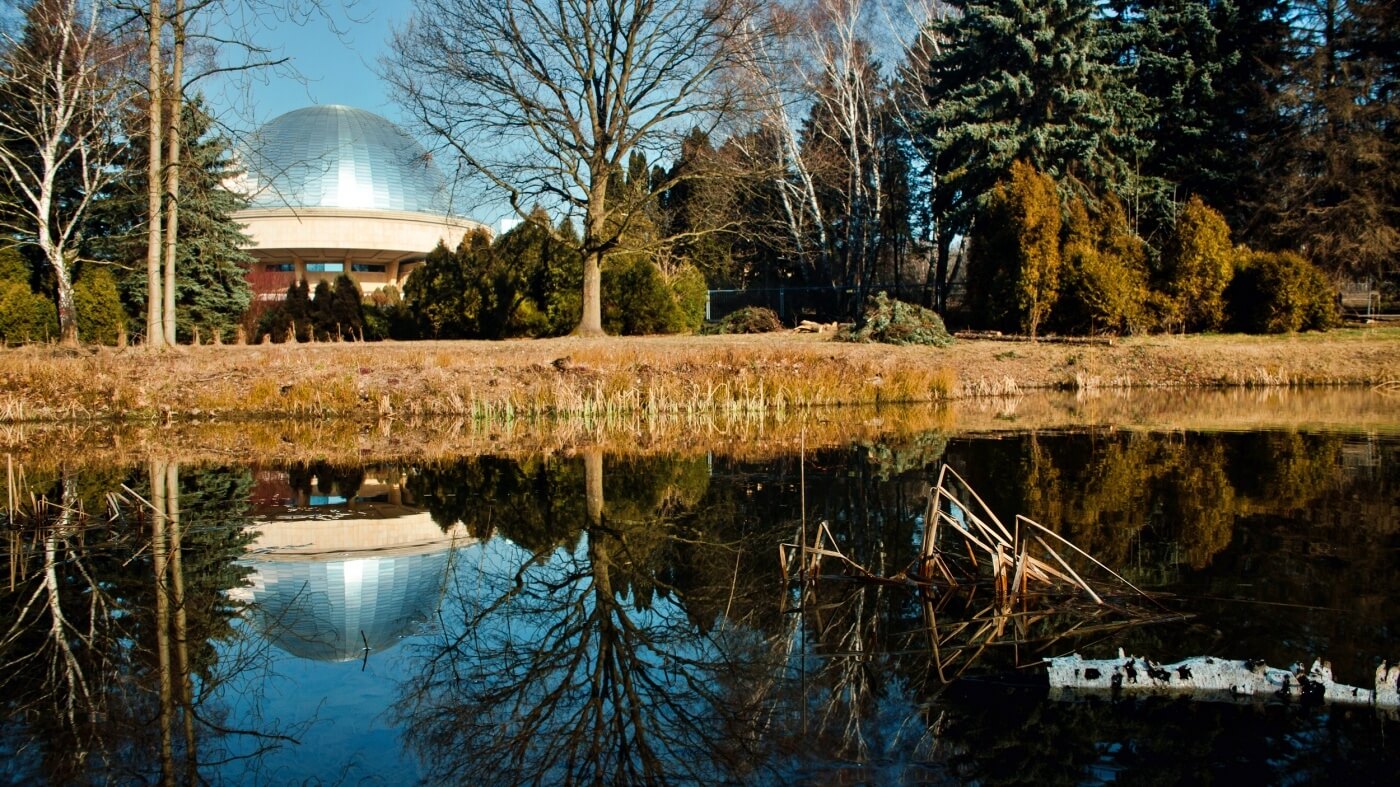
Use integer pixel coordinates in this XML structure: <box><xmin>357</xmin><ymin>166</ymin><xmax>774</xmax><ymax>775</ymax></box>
<box><xmin>242</xmin><ymin>104</ymin><xmax>449</xmax><ymax>216</ymax></box>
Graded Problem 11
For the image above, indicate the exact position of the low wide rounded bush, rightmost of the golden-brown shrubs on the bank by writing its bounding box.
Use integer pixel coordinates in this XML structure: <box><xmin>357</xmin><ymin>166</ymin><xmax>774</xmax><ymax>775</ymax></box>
<box><xmin>1225</xmin><ymin>246</ymin><xmax>1340</xmax><ymax>333</ymax></box>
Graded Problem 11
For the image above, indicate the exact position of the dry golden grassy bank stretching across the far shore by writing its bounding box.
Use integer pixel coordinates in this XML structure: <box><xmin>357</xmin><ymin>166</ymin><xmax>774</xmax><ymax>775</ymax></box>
<box><xmin>0</xmin><ymin>329</ymin><xmax>1400</xmax><ymax>424</ymax></box>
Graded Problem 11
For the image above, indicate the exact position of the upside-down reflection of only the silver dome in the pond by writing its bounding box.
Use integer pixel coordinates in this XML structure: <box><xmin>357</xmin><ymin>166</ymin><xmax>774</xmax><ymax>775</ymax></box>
<box><xmin>240</xmin><ymin>552</ymin><xmax>451</xmax><ymax>661</ymax></box>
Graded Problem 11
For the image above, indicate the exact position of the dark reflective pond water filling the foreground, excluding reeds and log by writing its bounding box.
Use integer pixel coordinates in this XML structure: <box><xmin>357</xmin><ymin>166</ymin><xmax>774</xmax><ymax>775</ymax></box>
<box><xmin>0</xmin><ymin>420</ymin><xmax>1400</xmax><ymax>784</ymax></box>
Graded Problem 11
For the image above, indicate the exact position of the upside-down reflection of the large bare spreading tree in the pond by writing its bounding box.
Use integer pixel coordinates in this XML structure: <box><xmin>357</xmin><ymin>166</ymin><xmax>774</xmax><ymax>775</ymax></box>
<box><xmin>400</xmin><ymin>452</ymin><xmax>784</xmax><ymax>783</ymax></box>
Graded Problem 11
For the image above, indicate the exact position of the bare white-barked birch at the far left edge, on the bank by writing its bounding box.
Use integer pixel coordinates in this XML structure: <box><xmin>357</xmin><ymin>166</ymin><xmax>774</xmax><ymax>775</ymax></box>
<box><xmin>0</xmin><ymin>0</ymin><xmax>130</xmax><ymax>343</ymax></box>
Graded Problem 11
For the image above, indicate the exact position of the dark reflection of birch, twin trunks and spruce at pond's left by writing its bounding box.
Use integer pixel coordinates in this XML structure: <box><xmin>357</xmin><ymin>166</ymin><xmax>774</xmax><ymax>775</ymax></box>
<box><xmin>0</xmin><ymin>462</ymin><xmax>270</xmax><ymax>783</ymax></box>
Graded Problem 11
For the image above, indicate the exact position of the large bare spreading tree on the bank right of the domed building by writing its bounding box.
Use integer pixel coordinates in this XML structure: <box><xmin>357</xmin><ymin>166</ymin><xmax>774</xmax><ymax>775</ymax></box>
<box><xmin>384</xmin><ymin>0</ymin><xmax>767</xmax><ymax>335</ymax></box>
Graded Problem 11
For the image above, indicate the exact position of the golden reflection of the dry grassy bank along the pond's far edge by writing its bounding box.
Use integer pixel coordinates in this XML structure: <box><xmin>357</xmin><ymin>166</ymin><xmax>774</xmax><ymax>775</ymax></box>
<box><xmin>0</xmin><ymin>386</ymin><xmax>1400</xmax><ymax>469</ymax></box>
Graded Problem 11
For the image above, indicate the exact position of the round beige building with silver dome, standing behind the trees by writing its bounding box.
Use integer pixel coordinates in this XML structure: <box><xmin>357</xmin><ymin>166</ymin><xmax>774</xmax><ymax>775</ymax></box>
<box><xmin>235</xmin><ymin>105</ymin><xmax>484</xmax><ymax>294</ymax></box>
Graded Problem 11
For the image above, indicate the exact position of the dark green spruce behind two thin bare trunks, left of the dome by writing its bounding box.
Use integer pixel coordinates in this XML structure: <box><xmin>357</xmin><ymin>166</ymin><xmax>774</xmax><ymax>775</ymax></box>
<box><xmin>88</xmin><ymin>97</ymin><xmax>252</xmax><ymax>340</ymax></box>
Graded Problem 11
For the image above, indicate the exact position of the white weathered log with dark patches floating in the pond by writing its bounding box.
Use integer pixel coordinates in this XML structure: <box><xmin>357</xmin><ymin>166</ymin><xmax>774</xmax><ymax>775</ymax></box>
<box><xmin>1044</xmin><ymin>650</ymin><xmax>1400</xmax><ymax>709</ymax></box>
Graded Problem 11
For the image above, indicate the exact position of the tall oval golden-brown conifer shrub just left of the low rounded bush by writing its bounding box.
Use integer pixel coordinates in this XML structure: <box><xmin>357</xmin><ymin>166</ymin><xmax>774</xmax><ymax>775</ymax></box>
<box><xmin>1159</xmin><ymin>196</ymin><xmax>1236</xmax><ymax>330</ymax></box>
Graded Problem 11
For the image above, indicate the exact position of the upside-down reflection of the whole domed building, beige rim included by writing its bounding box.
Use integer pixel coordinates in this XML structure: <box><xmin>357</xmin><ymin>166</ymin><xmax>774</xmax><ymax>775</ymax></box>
<box><xmin>232</xmin><ymin>465</ymin><xmax>475</xmax><ymax>661</ymax></box>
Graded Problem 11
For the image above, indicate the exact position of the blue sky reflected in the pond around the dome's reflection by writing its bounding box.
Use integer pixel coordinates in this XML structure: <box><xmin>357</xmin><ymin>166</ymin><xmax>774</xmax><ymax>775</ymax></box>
<box><xmin>221</xmin><ymin>529</ymin><xmax>745</xmax><ymax>784</ymax></box>
